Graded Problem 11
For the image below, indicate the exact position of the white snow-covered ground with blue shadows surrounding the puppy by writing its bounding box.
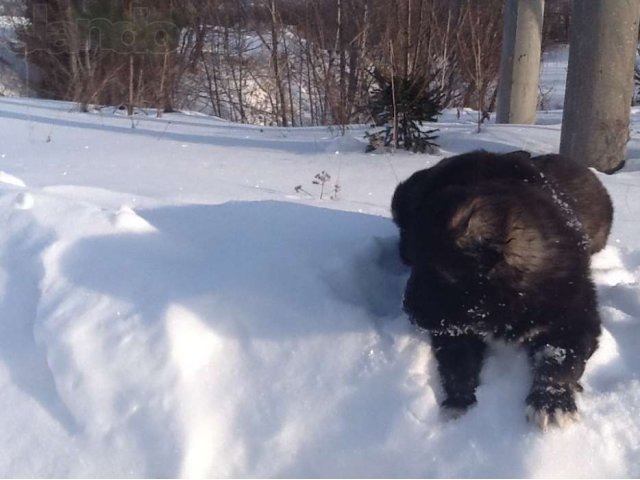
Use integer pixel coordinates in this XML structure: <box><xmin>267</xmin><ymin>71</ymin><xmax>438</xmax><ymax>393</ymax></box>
<box><xmin>0</xmin><ymin>73</ymin><xmax>640</xmax><ymax>477</ymax></box>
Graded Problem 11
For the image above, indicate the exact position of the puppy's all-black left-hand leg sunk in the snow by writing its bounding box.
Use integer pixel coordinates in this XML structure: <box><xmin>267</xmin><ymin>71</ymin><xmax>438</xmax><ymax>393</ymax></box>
<box><xmin>431</xmin><ymin>332</ymin><xmax>487</xmax><ymax>418</ymax></box>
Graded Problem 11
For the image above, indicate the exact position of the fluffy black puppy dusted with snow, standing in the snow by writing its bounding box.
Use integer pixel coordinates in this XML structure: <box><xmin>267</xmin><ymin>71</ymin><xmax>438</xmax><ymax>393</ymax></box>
<box><xmin>392</xmin><ymin>151</ymin><xmax>612</xmax><ymax>428</ymax></box>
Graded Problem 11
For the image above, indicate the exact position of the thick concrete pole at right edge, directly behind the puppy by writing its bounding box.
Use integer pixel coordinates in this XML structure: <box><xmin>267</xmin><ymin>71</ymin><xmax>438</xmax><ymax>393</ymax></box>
<box><xmin>560</xmin><ymin>0</ymin><xmax>640</xmax><ymax>173</ymax></box>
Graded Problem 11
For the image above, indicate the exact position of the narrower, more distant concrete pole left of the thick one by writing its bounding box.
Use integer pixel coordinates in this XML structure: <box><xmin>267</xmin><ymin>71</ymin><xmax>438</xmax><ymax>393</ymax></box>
<box><xmin>496</xmin><ymin>0</ymin><xmax>544</xmax><ymax>124</ymax></box>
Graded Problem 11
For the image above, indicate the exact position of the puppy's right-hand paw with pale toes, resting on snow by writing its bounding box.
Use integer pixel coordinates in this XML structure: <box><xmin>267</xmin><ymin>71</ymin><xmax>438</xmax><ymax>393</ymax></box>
<box><xmin>525</xmin><ymin>385</ymin><xmax>578</xmax><ymax>431</ymax></box>
